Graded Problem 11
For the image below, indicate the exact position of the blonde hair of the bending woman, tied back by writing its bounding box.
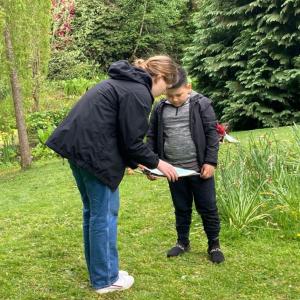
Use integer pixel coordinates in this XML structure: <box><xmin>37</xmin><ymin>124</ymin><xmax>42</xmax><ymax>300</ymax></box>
<box><xmin>133</xmin><ymin>55</ymin><xmax>178</xmax><ymax>85</ymax></box>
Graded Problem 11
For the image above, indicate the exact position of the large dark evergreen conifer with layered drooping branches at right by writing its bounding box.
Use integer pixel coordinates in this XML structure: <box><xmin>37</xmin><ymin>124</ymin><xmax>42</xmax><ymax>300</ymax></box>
<box><xmin>185</xmin><ymin>0</ymin><xmax>300</xmax><ymax>129</ymax></box>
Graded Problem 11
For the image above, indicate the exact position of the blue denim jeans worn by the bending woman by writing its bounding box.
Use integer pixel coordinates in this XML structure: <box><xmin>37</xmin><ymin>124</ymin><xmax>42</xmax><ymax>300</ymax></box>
<box><xmin>69</xmin><ymin>161</ymin><xmax>119</xmax><ymax>289</ymax></box>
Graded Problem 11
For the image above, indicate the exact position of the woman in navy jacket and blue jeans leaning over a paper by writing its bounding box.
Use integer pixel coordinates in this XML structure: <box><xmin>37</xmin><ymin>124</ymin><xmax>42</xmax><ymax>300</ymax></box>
<box><xmin>46</xmin><ymin>56</ymin><xmax>177</xmax><ymax>293</ymax></box>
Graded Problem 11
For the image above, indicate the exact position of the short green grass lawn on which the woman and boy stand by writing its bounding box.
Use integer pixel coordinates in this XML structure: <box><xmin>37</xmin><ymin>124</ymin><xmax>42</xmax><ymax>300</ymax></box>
<box><xmin>0</xmin><ymin>129</ymin><xmax>300</xmax><ymax>300</ymax></box>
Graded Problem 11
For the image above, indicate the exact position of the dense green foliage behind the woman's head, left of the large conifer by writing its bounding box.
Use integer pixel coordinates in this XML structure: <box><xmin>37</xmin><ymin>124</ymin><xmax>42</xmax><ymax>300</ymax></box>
<box><xmin>50</xmin><ymin>0</ymin><xmax>194</xmax><ymax>75</ymax></box>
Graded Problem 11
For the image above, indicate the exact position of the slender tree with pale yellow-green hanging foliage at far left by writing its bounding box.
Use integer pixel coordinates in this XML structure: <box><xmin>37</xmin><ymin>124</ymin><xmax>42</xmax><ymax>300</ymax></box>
<box><xmin>0</xmin><ymin>0</ymin><xmax>51</xmax><ymax>168</ymax></box>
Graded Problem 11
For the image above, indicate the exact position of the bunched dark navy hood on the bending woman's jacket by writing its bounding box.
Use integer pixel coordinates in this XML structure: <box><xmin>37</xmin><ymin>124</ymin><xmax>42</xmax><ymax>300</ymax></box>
<box><xmin>108</xmin><ymin>60</ymin><xmax>152</xmax><ymax>91</ymax></box>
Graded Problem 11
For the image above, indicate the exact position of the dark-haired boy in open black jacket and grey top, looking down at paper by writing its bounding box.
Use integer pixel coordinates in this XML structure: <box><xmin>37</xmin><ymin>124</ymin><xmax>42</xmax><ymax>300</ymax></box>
<box><xmin>147</xmin><ymin>68</ymin><xmax>224</xmax><ymax>263</ymax></box>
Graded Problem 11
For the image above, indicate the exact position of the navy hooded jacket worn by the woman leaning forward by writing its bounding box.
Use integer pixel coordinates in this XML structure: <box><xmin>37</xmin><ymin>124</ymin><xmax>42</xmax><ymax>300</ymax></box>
<box><xmin>46</xmin><ymin>61</ymin><xmax>159</xmax><ymax>190</ymax></box>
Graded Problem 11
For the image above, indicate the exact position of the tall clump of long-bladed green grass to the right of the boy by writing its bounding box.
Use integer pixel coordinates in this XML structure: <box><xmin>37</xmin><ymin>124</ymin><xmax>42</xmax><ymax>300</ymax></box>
<box><xmin>216</xmin><ymin>125</ymin><xmax>300</xmax><ymax>236</ymax></box>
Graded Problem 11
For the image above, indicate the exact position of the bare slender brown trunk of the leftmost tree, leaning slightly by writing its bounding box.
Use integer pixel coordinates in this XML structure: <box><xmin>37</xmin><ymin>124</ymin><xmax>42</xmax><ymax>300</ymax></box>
<box><xmin>4</xmin><ymin>25</ymin><xmax>31</xmax><ymax>169</ymax></box>
